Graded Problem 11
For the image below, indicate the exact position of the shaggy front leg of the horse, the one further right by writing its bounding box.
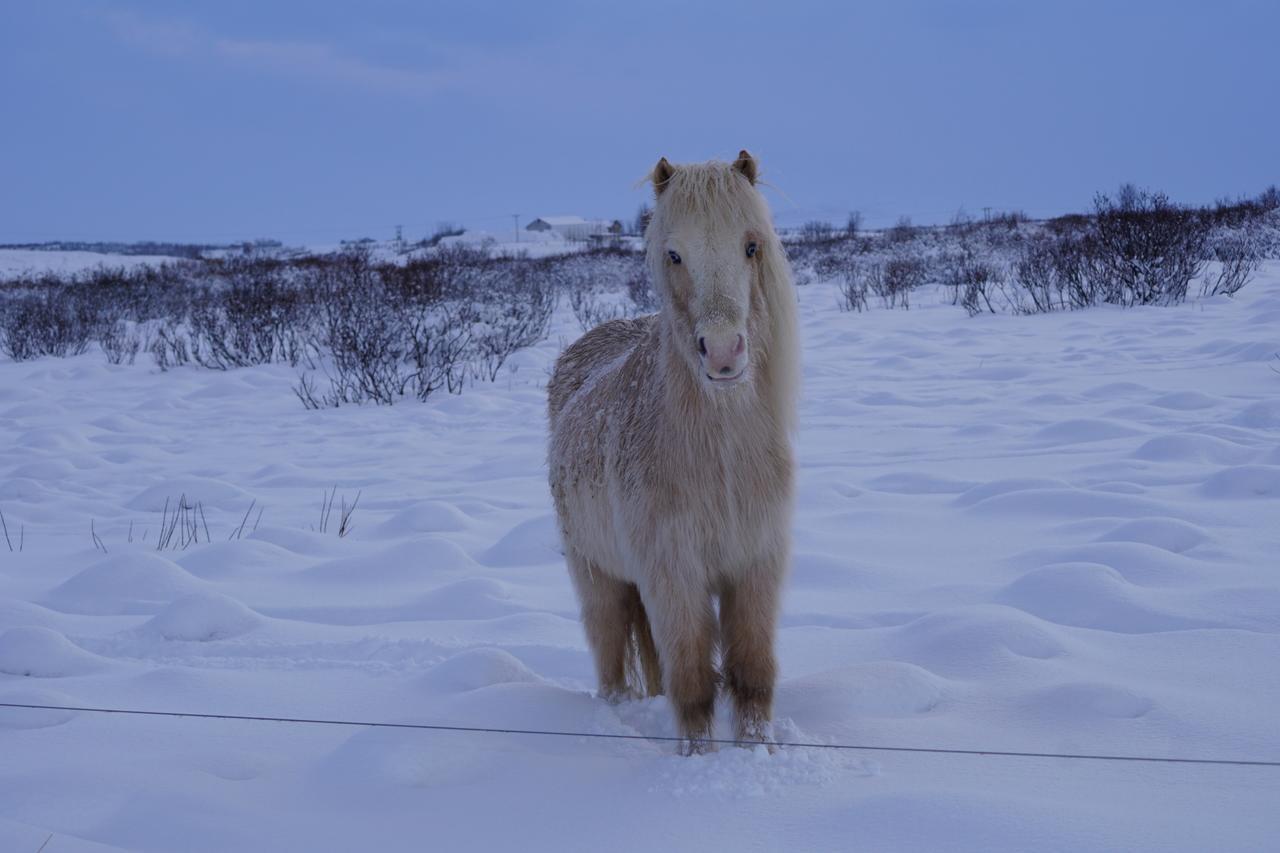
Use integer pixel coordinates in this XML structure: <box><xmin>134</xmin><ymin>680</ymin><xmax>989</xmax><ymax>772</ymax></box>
<box><xmin>721</xmin><ymin>561</ymin><xmax>782</xmax><ymax>742</ymax></box>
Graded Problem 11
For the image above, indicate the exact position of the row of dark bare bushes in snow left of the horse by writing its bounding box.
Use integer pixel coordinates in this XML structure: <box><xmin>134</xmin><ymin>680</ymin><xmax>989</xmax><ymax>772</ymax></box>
<box><xmin>0</xmin><ymin>246</ymin><xmax>653</xmax><ymax>407</ymax></box>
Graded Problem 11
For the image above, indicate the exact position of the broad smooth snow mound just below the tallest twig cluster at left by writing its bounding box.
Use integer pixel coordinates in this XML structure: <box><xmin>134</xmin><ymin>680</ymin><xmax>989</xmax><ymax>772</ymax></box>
<box><xmin>49</xmin><ymin>551</ymin><xmax>206</xmax><ymax>616</ymax></box>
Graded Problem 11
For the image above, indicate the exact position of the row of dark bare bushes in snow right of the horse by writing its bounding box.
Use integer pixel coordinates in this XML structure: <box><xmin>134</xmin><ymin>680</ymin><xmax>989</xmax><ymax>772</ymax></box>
<box><xmin>788</xmin><ymin>186</ymin><xmax>1280</xmax><ymax>314</ymax></box>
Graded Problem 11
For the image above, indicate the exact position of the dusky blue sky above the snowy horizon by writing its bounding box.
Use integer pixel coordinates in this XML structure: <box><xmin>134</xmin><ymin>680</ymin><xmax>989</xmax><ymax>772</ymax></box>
<box><xmin>0</xmin><ymin>0</ymin><xmax>1280</xmax><ymax>243</ymax></box>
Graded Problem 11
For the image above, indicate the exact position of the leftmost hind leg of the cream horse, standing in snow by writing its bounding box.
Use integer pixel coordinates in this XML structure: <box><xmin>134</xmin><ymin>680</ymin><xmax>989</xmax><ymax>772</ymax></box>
<box><xmin>564</xmin><ymin>548</ymin><xmax>635</xmax><ymax>702</ymax></box>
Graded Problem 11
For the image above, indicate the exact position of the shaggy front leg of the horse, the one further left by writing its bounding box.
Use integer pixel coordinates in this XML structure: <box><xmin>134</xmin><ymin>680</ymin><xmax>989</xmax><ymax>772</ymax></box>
<box><xmin>640</xmin><ymin>573</ymin><xmax>716</xmax><ymax>754</ymax></box>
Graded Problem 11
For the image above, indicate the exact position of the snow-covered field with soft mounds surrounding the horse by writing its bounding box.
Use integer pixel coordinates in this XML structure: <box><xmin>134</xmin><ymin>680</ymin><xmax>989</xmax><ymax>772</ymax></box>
<box><xmin>0</xmin><ymin>263</ymin><xmax>1280</xmax><ymax>853</ymax></box>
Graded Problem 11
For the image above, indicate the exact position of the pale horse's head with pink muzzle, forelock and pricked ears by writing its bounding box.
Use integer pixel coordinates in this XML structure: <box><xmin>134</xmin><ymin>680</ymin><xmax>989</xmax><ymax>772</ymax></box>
<box><xmin>645</xmin><ymin>151</ymin><xmax>781</xmax><ymax>386</ymax></box>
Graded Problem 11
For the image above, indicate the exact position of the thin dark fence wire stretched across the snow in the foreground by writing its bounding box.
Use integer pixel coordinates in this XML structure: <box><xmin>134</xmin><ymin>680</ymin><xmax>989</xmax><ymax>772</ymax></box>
<box><xmin>0</xmin><ymin>702</ymin><xmax>1280</xmax><ymax>767</ymax></box>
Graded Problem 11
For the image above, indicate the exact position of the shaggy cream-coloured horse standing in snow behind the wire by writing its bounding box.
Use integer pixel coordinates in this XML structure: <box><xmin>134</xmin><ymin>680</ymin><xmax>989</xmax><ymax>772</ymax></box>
<box><xmin>548</xmin><ymin>151</ymin><xmax>800</xmax><ymax>754</ymax></box>
